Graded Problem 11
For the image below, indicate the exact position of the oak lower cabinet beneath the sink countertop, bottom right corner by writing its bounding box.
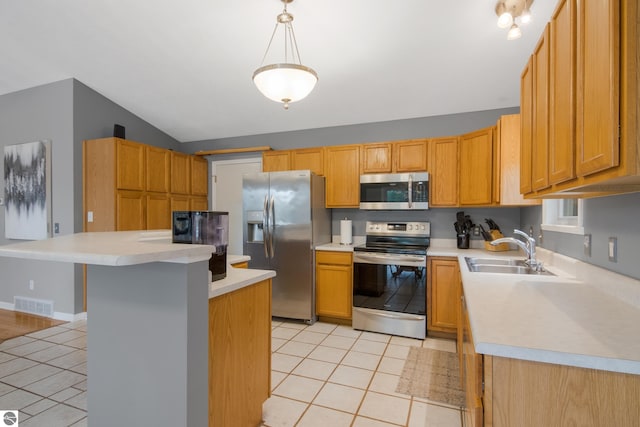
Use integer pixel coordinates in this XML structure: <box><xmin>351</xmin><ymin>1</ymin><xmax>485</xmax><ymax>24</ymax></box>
<box><xmin>458</xmin><ymin>288</ymin><xmax>640</xmax><ymax>427</ymax></box>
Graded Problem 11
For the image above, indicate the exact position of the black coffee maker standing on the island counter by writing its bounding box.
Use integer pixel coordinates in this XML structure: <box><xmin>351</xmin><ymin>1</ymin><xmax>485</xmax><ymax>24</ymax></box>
<box><xmin>172</xmin><ymin>211</ymin><xmax>229</xmax><ymax>281</ymax></box>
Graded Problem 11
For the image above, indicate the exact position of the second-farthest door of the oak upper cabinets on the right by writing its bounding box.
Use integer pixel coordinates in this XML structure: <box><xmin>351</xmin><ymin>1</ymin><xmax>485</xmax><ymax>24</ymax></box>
<box><xmin>531</xmin><ymin>25</ymin><xmax>549</xmax><ymax>191</ymax></box>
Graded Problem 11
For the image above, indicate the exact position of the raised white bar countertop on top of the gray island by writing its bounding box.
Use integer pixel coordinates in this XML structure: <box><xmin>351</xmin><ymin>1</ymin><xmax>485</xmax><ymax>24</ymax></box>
<box><xmin>0</xmin><ymin>230</ymin><xmax>214</xmax><ymax>266</ymax></box>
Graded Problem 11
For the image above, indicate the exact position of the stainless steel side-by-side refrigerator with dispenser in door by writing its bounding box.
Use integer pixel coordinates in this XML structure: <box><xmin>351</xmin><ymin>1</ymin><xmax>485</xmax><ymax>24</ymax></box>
<box><xmin>242</xmin><ymin>170</ymin><xmax>331</xmax><ymax>323</ymax></box>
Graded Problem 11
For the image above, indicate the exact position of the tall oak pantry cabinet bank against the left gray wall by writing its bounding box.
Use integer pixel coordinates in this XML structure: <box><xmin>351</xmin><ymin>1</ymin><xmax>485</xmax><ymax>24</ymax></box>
<box><xmin>83</xmin><ymin>138</ymin><xmax>208</xmax><ymax>231</ymax></box>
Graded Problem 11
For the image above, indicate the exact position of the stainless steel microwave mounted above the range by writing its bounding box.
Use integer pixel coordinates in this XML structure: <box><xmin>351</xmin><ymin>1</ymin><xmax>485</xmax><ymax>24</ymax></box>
<box><xmin>360</xmin><ymin>172</ymin><xmax>429</xmax><ymax>210</ymax></box>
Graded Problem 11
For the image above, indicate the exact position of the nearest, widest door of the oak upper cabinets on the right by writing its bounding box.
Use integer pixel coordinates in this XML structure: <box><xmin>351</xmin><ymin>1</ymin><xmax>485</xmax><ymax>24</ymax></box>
<box><xmin>576</xmin><ymin>0</ymin><xmax>620</xmax><ymax>176</ymax></box>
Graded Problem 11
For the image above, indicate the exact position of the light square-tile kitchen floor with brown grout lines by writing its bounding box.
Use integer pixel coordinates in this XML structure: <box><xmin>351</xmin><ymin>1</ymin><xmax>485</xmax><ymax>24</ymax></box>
<box><xmin>0</xmin><ymin>321</ymin><xmax>462</xmax><ymax>427</ymax></box>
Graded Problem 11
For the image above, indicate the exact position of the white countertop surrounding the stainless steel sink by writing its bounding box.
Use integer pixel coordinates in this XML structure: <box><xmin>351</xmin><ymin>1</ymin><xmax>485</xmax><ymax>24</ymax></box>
<box><xmin>456</xmin><ymin>248</ymin><xmax>640</xmax><ymax>374</ymax></box>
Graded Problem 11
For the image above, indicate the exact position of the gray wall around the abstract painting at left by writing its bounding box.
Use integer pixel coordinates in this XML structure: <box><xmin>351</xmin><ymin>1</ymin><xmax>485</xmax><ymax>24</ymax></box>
<box><xmin>0</xmin><ymin>79</ymin><xmax>181</xmax><ymax>313</ymax></box>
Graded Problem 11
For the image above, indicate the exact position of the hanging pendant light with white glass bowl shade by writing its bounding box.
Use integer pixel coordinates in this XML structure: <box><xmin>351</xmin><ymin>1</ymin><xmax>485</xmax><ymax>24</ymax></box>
<box><xmin>253</xmin><ymin>0</ymin><xmax>318</xmax><ymax>110</ymax></box>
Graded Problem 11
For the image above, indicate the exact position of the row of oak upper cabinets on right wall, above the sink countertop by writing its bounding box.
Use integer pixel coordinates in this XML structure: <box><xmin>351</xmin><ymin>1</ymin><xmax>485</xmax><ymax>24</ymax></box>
<box><xmin>521</xmin><ymin>0</ymin><xmax>640</xmax><ymax>198</ymax></box>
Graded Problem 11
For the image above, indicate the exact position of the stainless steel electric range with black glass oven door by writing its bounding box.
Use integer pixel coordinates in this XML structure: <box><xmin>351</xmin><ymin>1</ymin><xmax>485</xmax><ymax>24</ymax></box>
<box><xmin>352</xmin><ymin>221</ymin><xmax>431</xmax><ymax>339</ymax></box>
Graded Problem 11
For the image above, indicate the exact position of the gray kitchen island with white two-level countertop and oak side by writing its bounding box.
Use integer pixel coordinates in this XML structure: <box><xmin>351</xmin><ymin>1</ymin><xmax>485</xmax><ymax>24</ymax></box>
<box><xmin>0</xmin><ymin>231</ymin><xmax>275</xmax><ymax>427</ymax></box>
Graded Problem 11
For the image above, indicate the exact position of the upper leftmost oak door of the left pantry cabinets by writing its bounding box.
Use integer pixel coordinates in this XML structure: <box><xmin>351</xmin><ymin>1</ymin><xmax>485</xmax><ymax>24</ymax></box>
<box><xmin>116</xmin><ymin>139</ymin><xmax>145</xmax><ymax>191</ymax></box>
